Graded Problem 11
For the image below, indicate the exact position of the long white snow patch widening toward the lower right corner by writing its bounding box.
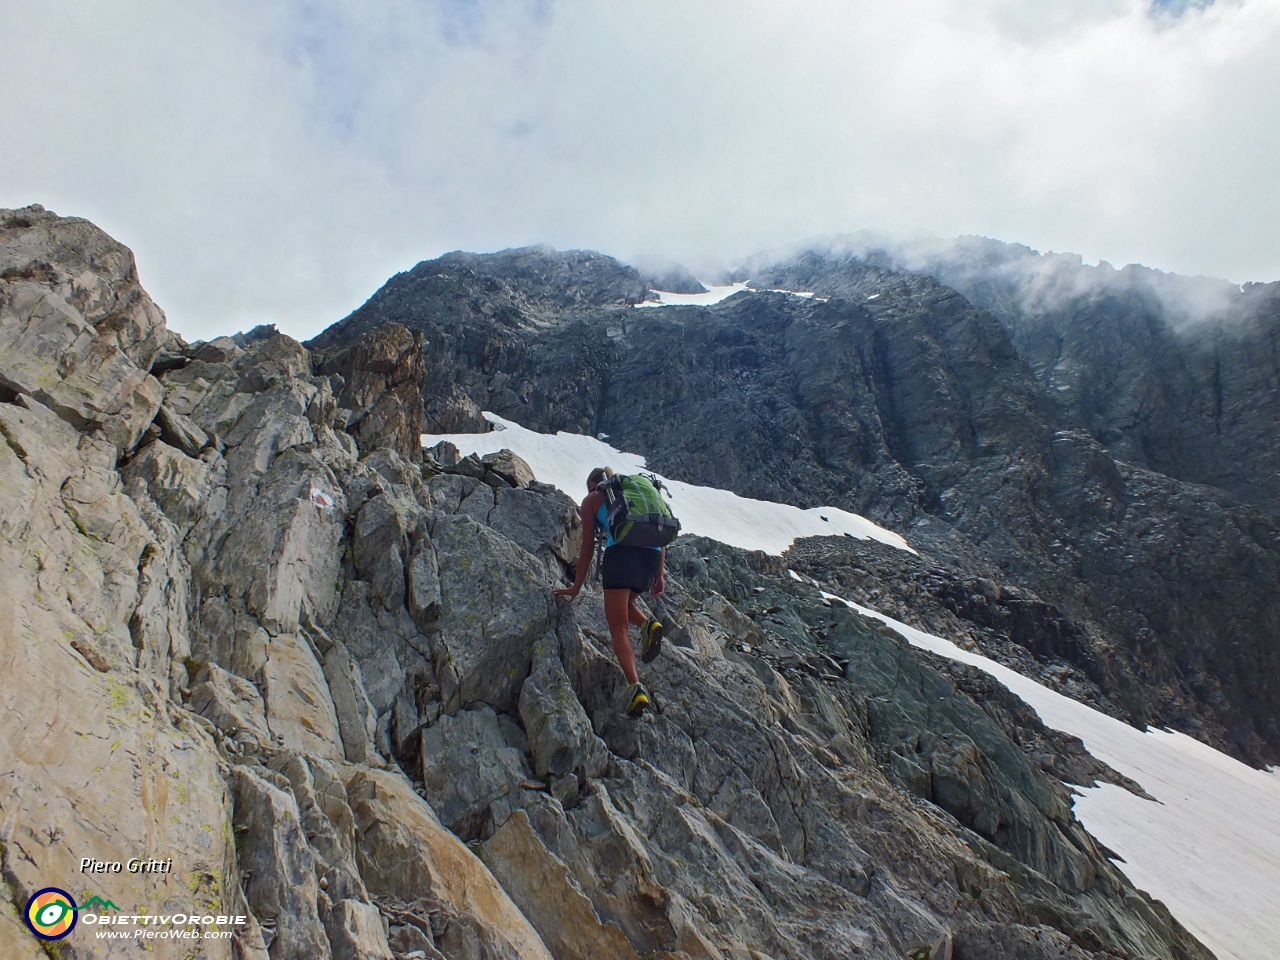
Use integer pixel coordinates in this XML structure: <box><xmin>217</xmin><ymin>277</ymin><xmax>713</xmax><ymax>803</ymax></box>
<box><xmin>823</xmin><ymin>591</ymin><xmax>1280</xmax><ymax>960</ymax></box>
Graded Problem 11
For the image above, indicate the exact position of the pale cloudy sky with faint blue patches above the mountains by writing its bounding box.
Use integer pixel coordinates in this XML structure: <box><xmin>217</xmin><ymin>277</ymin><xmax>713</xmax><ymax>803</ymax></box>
<box><xmin>0</xmin><ymin>0</ymin><xmax>1280</xmax><ymax>338</ymax></box>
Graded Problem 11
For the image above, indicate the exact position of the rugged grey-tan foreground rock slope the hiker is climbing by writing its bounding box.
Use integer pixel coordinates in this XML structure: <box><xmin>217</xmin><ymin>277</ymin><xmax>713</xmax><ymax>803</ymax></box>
<box><xmin>0</xmin><ymin>207</ymin><xmax>1210</xmax><ymax>960</ymax></box>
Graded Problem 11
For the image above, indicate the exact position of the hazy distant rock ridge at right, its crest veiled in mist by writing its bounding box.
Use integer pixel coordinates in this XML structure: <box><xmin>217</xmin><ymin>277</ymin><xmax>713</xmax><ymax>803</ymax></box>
<box><xmin>865</xmin><ymin>237</ymin><xmax>1280</xmax><ymax>508</ymax></box>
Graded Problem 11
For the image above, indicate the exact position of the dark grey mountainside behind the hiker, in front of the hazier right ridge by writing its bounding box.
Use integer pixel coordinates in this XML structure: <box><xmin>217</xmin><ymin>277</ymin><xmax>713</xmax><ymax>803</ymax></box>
<box><xmin>314</xmin><ymin>251</ymin><xmax>1280</xmax><ymax>763</ymax></box>
